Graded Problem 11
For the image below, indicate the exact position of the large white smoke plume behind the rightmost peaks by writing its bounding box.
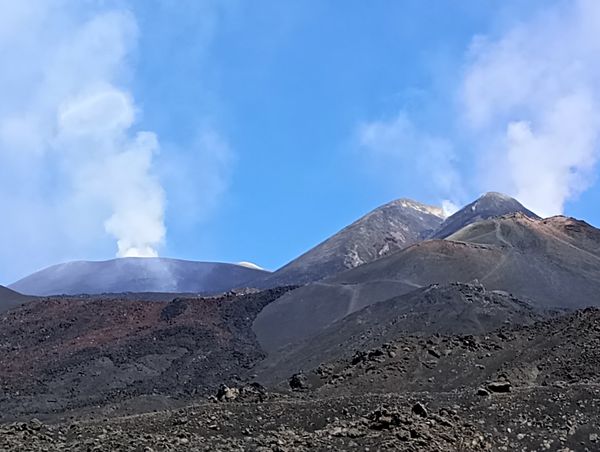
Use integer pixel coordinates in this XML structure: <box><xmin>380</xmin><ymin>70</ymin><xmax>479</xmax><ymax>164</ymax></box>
<box><xmin>461</xmin><ymin>0</ymin><xmax>600</xmax><ymax>216</ymax></box>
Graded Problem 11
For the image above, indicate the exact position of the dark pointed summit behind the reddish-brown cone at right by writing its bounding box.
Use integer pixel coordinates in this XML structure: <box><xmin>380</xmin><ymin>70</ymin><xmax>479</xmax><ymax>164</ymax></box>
<box><xmin>429</xmin><ymin>192</ymin><xmax>539</xmax><ymax>239</ymax></box>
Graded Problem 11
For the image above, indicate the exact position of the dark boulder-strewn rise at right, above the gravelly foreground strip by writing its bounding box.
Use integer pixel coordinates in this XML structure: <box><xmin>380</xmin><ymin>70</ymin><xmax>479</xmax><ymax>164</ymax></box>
<box><xmin>307</xmin><ymin>308</ymin><xmax>600</xmax><ymax>397</ymax></box>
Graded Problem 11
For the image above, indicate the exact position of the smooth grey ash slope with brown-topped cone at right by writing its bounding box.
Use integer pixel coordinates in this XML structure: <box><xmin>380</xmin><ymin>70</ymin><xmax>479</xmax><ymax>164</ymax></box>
<box><xmin>254</xmin><ymin>214</ymin><xmax>600</xmax><ymax>352</ymax></box>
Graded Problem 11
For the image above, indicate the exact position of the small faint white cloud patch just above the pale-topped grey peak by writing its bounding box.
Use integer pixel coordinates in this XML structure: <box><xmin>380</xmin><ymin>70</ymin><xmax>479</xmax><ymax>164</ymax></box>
<box><xmin>358</xmin><ymin>112</ymin><xmax>464</xmax><ymax>211</ymax></box>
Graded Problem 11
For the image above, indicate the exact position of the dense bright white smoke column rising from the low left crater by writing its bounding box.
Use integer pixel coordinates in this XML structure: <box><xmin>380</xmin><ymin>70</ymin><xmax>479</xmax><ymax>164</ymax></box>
<box><xmin>55</xmin><ymin>86</ymin><xmax>165</xmax><ymax>257</ymax></box>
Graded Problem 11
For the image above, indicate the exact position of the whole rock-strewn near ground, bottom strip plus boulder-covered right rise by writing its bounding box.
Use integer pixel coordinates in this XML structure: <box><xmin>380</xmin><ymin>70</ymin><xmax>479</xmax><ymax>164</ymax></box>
<box><xmin>0</xmin><ymin>309</ymin><xmax>600</xmax><ymax>452</ymax></box>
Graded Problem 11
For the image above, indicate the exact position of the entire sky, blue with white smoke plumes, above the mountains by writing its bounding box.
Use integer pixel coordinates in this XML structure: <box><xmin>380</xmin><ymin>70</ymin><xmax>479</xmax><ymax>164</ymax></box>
<box><xmin>0</xmin><ymin>0</ymin><xmax>600</xmax><ymax>283</ymax></box>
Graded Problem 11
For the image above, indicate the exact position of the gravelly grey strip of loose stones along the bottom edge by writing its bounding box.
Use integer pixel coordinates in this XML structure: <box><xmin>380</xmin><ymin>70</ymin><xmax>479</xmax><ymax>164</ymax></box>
<box><xmin>0</xmin><ymin>384</ymin><xmax>600</xmax><ymax>452</ymax></box>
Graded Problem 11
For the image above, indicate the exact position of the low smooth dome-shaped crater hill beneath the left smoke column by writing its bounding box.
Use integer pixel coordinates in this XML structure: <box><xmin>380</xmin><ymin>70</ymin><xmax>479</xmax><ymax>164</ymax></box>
<box><xmin>10</xmin><ymin>258</ymin><xmax>268</xmax><ymax>296</ymax></box>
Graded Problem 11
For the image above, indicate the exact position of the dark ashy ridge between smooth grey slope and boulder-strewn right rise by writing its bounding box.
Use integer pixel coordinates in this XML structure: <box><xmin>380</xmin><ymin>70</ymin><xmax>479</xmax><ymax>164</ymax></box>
<box><xmin>257</xmin><ymin>283</ymin><xmax>557</xmax><ymax>384</ymax></box>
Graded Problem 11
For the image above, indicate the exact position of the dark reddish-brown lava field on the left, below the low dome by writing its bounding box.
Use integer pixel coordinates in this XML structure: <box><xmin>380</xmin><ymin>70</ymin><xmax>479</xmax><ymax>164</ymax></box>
<box><xmin>0</xmin><ymin>288</ymin><xmax>287</xmax><ymax>421</ymax></box>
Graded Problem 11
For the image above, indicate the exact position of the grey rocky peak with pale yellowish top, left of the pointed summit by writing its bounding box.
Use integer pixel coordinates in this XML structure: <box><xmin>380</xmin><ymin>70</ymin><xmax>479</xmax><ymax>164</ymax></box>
<box><xmin>260</xmin><ymin>199</ymin><xmax>443</xmax><ymax>286</ymax></box>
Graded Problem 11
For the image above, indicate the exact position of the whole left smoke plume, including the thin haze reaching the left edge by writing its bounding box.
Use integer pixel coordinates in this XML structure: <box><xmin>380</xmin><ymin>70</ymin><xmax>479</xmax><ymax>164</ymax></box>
<box><xmin>0</xmin><ymin>0</ymin><xmax>165</xmax><ymax>275</ymax></box>
